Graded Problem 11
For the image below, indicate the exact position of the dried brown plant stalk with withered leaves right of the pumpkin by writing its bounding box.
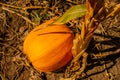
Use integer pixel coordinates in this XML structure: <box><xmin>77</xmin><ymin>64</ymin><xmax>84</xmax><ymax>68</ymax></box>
<box><xmin>65</xmin><ymin>0</ymin><xmax>120</xmax><ymax>80</ymax></box>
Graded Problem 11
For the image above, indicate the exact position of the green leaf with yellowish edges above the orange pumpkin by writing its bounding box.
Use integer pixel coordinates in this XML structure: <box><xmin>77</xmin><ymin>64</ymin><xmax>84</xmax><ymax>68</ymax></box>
<box><xmin>53</xmin><ymin>5</ymin><xmax>86</xmax><ymax>24</ymax></box>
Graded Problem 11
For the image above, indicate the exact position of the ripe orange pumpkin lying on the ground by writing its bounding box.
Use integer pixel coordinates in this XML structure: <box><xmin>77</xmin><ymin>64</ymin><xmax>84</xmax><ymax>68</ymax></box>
<box><xmin>23</xmin><ymin>19</ymin><xmax>74</xmax><ymax>72</ymax></box>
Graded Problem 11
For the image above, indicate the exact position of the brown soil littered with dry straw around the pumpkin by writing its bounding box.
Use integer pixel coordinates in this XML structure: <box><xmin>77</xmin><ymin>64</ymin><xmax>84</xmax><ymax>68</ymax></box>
<box><xmin>0</xmin><ymin>0</ymin><xmax>120</xmax><ymax>80</ymax></box>
